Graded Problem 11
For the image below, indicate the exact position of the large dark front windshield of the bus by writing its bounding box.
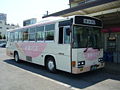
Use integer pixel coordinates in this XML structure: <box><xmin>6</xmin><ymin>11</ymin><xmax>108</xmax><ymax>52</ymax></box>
<box><xmin>73</xmin><ymin>25</ymin><xmax>102</xmax><ymax>49</ymax></box>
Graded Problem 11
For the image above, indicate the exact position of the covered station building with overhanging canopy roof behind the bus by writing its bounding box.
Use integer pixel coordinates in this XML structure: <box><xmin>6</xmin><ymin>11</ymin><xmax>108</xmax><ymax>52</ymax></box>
<box><xmin>43</xmin><ymin>0</ymin><xmax>120</xmax><ymax>63</ymax></box>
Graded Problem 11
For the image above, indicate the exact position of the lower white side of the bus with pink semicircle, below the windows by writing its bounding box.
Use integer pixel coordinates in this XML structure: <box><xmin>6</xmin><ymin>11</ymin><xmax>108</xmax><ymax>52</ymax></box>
<box><xmin>7</xmin><ymin>42</ymin><xmax>71</xmax><ymax>72</ymax></box>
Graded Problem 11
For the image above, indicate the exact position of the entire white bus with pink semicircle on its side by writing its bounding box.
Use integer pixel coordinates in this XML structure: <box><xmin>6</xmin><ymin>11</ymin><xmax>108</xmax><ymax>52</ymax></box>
<box><xmin>6</xmin><ymin>16</ymin><xmax>104</xmax><ymax>74</ymax></box>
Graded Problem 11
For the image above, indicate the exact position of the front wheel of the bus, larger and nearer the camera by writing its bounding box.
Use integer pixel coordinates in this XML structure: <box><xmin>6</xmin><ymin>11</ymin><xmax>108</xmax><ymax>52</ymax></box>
<box><xmin>46</xmin><ymin>57</ymin><xmax>56</xmax><ymax>73</ymax></box>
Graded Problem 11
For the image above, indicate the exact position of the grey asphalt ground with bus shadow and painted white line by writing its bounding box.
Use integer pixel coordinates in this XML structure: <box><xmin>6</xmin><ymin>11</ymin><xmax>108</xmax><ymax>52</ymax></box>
<box><xmin>0</xmin><ymin>48</ymin><xmax>120</xmax><ymax>90</ymax></box>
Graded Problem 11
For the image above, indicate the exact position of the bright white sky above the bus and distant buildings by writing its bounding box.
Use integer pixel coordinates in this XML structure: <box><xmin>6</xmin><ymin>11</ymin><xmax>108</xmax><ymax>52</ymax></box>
<box><xmin>0</xmin><ymin>0</ymin><xmax>69</xmax><ymax>26</ymax></box>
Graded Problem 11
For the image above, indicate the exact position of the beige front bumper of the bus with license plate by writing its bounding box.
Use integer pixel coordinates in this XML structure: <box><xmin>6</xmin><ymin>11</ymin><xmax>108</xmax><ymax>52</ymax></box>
<box><xmin>72</xmin><ymin>63</ymin><xmax>105</xmax><ymax>74</ymax></box>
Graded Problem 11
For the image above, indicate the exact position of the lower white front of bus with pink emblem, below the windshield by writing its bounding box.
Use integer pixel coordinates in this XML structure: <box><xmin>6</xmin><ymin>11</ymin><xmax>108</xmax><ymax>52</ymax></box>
<box><xmin>72</xmin><ymin>48</ymin><xmax>104</xmax><ymax>74</ymax></box>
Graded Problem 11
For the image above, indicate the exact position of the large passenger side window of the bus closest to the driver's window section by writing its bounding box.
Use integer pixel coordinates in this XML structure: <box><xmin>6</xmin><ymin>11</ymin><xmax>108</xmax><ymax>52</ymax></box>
<box><xmin>45</xmin><ymin>24</ymin><xmax>55</xmax><ymax>40</ymax></box>
